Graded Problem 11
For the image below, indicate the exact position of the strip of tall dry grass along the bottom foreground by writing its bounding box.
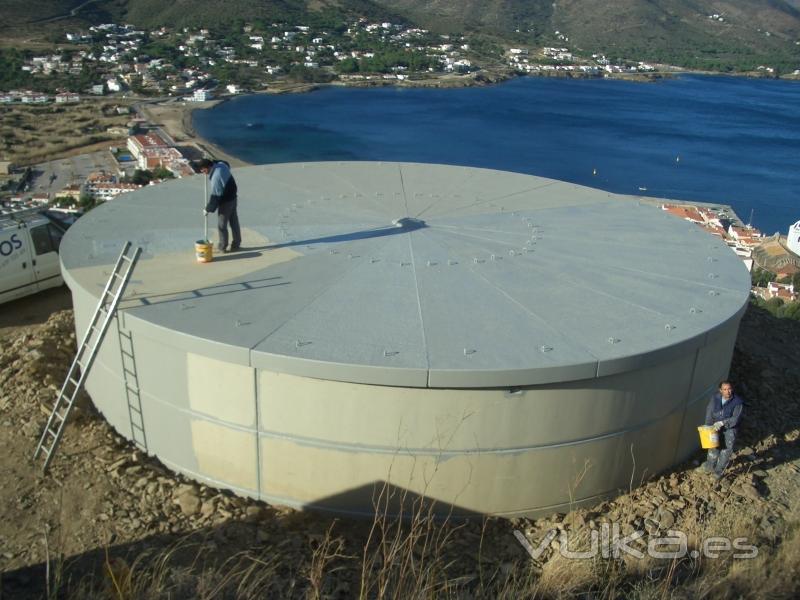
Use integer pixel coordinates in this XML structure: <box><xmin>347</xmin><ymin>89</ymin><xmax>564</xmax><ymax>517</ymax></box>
<box><xmin>31</xmin><ymin>482</ymin><xmax>800</xmax><ymax>600</ymax></box>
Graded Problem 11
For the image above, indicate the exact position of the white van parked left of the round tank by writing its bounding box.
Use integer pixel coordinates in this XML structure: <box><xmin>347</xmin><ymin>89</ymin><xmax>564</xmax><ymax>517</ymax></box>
<box><xmin>0</xmin><ymin>209</ymin><xmax>72</xmax><ymax>304</ymax></box>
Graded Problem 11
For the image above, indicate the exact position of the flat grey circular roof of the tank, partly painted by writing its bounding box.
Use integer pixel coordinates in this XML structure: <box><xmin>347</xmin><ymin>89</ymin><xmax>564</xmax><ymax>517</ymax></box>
<box><xmin>61</xmin><ymin>162</ymin><xmax>750</xmax><ymax>388</ymax></box>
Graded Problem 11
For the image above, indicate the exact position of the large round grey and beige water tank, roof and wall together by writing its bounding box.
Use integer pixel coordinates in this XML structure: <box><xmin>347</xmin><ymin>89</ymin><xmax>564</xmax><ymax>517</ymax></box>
<box><xmin>61</xmin><ymin>162</ymin><xmax>749</xmax><ymax>515</ymax></box>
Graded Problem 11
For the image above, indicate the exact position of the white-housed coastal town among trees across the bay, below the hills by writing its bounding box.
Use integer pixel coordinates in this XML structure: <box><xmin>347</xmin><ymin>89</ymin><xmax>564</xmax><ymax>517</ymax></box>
<box><xmin>0</xmin><ymin>13</ymin><xmax>700</xmax><ymax>103</ymax></box>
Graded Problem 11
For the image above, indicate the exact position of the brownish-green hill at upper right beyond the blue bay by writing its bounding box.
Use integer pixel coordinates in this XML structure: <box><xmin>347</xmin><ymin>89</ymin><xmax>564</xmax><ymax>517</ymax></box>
<box><xmin>376</xmin><ymin>0</ymin><xmax>800</xmax><ymax>70</ymax></box>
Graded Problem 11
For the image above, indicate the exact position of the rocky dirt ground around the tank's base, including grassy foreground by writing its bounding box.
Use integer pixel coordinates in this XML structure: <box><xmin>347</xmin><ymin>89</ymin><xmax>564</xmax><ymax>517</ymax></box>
<box><xmin>0</xmin><ymin>299</ymin><xmax>800</xmax><ymax>599</ymax></box>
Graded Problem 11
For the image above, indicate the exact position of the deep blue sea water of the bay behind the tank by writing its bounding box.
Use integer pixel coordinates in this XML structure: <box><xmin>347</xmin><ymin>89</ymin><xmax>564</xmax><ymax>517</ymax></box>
<box><xmin>193</xmin><ymin>75</ymin><xmax>800</xmax><ymax>234</ymax></box>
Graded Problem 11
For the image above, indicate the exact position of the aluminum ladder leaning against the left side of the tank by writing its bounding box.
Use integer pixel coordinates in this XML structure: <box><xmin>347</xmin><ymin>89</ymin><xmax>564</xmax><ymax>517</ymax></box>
<box><xmin>33</xmin><ymin>242</ymin><xmax>142</xmax><ymax>471</ymax></box>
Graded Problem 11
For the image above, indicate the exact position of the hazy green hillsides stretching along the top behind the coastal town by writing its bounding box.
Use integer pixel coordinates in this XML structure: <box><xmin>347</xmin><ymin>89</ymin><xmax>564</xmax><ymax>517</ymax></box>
<box><xmin>0</xmin><ymin>0</ymin><xmax>800</xmax><ymax>71</ymax></box>
